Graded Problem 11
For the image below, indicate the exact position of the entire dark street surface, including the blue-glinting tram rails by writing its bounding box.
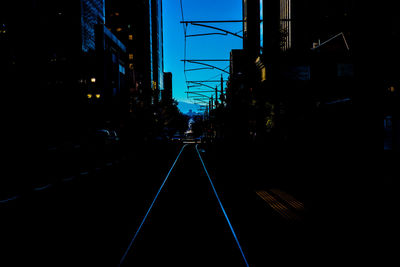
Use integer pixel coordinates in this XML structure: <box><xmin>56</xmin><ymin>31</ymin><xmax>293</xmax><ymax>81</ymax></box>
<box><xmin>0</xmin><ymin>144</ymin><xmax>395</xmax><ymax>267</ymax></box>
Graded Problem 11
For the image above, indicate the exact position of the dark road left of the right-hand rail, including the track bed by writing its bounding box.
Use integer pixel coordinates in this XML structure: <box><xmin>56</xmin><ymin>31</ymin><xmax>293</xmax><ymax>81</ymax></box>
<box><xmin>1</xmin><ymin>144</ymin><xmax>247</xmax><ymax>266</ymax></box>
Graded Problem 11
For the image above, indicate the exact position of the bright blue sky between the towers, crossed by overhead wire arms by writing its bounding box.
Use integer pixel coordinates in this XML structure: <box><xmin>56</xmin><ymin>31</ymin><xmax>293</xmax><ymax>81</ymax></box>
<box><xmin>163</xmin><ymin>0</ymin><xmax>242</xmax><ymax>111</ymax></box>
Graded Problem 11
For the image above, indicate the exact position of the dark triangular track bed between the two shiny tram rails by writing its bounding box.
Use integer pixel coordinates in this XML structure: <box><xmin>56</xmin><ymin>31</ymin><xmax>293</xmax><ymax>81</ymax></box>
<box><xmin>121</xmin><ymin>145</ymin><xmax>246</xmax><ymax>266</ymax></box>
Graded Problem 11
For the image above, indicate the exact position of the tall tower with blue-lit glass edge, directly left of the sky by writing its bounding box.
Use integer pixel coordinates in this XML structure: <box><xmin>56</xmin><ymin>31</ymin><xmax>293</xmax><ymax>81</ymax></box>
<box><xmin>106</xmin><ymin>0</ymin><xmax>163</xmax><ymax>105</ymax></box>
